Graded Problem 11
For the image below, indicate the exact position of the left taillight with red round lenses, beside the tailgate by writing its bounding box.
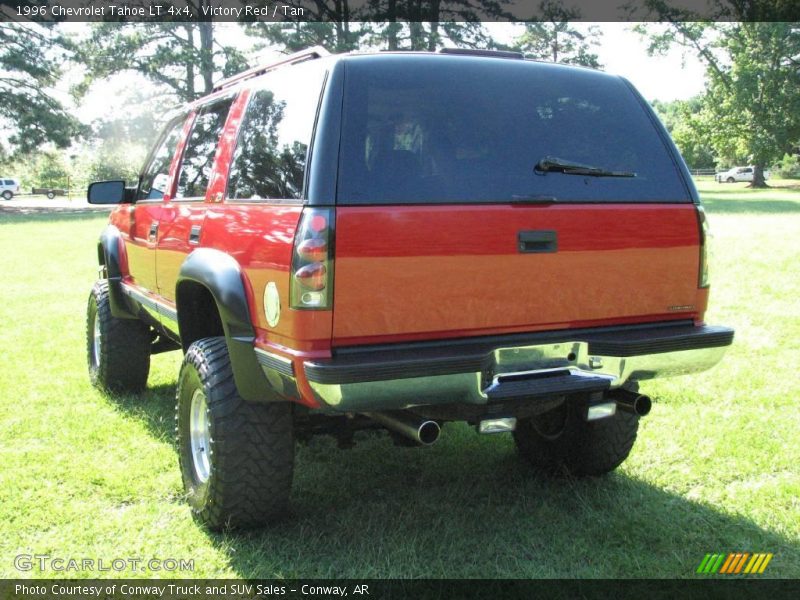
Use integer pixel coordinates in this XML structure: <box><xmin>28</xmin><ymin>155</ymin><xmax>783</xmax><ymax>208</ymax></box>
<box><xmin>289</xmin><ymin>207</ymin><xmax>333</xmax><ymax>310</ymax></box>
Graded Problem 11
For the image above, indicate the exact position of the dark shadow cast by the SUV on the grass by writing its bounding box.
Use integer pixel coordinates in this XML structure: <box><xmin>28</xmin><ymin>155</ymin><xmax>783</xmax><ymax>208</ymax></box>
<box><xmin>112</xmin><ymin>385</ymin><xmax>800</xmax><ymax>579</ymax></box>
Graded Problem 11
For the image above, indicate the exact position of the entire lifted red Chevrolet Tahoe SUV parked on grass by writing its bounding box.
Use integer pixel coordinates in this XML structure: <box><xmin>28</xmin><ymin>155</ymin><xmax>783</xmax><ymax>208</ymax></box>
<box><xmin>87</xmin><ymin>49</ymin><xmax>733</xmax><ymax>529</ymax></box>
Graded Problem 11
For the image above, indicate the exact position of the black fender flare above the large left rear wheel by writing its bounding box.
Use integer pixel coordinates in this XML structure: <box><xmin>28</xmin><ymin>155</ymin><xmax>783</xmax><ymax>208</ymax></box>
<box><xmin>175</xmin><ymin>248</ymin><xmax>282</xmax><ymax>402</ymax></box>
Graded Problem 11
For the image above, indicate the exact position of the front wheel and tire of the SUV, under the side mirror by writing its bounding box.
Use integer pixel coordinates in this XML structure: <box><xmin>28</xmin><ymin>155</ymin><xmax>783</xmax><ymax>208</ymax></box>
<box><xmin>86</xmin><ymin>280</ymin><xmax>153</xmax><ymax>393</ymax></box>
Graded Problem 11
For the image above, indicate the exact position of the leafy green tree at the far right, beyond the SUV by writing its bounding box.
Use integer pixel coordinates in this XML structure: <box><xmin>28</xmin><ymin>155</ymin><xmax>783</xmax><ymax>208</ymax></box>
<box><xmin>639</xmin><ymin>16</ymin><xmax>800</xmax><ymax>187</ymax></box>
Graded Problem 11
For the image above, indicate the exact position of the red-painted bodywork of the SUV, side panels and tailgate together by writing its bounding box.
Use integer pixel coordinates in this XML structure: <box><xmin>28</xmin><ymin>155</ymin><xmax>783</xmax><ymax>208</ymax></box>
<box><xmin>97</xmin><ymin>78</ymin><xmax>708</xmax><ymax>407</ymax></box>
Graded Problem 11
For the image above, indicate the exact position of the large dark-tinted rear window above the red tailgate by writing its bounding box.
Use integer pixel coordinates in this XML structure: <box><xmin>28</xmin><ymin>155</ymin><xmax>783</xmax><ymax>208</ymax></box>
<box><xmin>337</xmin><ymin>56</ymin><xmax>690</xmax><ymax>204</ymax></box>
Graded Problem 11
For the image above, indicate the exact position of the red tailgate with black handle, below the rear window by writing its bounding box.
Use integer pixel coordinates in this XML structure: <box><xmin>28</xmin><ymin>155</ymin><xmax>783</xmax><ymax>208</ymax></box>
<box><xmin>333</xmin><ymin>203</ymin><xmax>699</xmax><ymax>346</ymax></box>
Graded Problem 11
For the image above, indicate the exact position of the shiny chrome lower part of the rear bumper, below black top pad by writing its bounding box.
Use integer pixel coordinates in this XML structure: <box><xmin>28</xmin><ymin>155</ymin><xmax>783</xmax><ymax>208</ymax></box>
<box><xmin>306</xmin><ymin>342</ymin><xmax>727</xmax><ymax>412</ymax></box>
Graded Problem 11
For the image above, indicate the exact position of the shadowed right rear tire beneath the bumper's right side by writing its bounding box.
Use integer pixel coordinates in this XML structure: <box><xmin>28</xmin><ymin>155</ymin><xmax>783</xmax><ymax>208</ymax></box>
<box><xmin>514</xmin><ymin>398</ymin><xmax>639</xmax><ymax>477</ymax></box>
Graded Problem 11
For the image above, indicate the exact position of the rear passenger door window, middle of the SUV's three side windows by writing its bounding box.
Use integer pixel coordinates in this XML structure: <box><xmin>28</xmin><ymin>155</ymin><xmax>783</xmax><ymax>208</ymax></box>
<box><xmin>175</xmin><ymin>98</ymin><xmax>233</xmax><ymax>198</ymax></box>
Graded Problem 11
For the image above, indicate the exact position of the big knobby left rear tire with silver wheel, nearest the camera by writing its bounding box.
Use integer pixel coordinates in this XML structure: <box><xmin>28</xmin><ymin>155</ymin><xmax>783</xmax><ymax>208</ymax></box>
<box><xmin>176</xmin><ymin>337</ymin><xmax>294</xmax><ymax>530</ymax></box>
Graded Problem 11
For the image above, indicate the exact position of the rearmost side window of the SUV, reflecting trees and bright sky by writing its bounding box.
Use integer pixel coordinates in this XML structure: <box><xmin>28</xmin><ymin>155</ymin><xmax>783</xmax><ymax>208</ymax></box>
<box><xmin>228</xmin><ymin>62</ymin><xmax>325</xmax><ymax>200</ymax></box>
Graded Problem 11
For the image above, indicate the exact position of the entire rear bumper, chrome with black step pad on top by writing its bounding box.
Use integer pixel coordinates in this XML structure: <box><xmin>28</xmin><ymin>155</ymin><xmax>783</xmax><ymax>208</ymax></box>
<box><xmin>296</xmin><ymin>323</ymin><xmax>733</xmax><ymax>412</ymax></box>
